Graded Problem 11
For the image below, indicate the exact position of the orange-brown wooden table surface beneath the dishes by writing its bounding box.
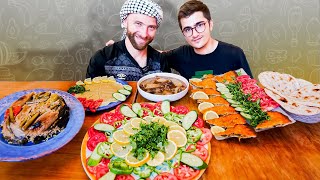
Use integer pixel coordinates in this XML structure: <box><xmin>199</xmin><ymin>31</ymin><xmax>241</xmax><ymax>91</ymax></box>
<box><xmin>0</xmin><ymin>81</ymin><xmax>320</xmax><ymax>180</ymax></box>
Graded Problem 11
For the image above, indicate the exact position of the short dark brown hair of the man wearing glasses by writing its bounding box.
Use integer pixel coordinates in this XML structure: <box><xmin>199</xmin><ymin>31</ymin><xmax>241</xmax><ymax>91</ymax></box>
<box><xmin>178</xmin><ymin>0</ymin><xmax>211</xmax><ymax>29</ymax></box>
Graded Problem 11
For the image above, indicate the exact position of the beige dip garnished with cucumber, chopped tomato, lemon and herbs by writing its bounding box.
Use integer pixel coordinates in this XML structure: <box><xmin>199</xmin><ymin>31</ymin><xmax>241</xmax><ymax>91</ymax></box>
<box><xmin>68</xmin><ymin>76</ymin><xmax>132</xmax><ymax>112</ymax></box>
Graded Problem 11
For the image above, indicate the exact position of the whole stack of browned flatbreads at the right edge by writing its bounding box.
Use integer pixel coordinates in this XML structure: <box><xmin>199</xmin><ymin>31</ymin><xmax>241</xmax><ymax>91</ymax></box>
<box><xmin>258</xmin><ymin>71</ymin><xmax>320</xmax><ymax>115</ymax></box>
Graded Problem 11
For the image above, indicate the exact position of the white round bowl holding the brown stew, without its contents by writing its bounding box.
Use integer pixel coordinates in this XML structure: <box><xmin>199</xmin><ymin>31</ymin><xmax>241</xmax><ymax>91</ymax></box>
<box><xmin>137</xmin><ymin>73</ymin><xmax>189</xmax><ymax>102</ymax></box>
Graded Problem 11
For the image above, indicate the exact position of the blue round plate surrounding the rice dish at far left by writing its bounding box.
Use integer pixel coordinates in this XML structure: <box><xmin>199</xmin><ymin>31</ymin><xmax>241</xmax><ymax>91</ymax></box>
<box><xmin>0</xmin><ymin>89</ymin><xmax>85</xmax><ymax>161</ymax></box>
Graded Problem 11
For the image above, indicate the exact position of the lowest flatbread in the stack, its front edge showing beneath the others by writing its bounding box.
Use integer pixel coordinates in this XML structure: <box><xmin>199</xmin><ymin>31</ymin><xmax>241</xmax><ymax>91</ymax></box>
<box><xmin>265</xmin><ymin>89</ymin><xmax>320</xmax><ymax>115</ymax></box>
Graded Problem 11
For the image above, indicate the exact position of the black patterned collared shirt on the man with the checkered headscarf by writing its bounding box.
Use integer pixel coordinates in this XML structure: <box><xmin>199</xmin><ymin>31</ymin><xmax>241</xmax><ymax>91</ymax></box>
<box><xmin>86</xmin><ymin>40</ymin><xmax>168</xmax><ymax>81</ymax></box>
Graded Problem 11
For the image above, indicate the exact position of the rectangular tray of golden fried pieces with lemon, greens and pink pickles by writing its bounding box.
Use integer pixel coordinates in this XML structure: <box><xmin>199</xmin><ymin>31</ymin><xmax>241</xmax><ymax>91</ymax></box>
<box><xmin>190</xmin><ymin>71</ymin><xmax>294</xmax><ymax>139</ymax></box>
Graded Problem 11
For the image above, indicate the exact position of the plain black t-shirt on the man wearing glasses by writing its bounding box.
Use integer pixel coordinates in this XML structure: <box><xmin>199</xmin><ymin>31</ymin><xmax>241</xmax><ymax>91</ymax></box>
<box><xmin>162</xmin><ymin>41</ymin><xmax>252</xmax><ymax>79</ymax></box>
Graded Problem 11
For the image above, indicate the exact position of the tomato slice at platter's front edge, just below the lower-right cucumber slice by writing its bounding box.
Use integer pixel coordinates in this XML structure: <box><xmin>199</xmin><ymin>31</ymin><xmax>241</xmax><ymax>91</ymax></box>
<box><xmin>173</xmin><ymin>163</ymin><xmax>200</xmax><ymax>180</ymax></box>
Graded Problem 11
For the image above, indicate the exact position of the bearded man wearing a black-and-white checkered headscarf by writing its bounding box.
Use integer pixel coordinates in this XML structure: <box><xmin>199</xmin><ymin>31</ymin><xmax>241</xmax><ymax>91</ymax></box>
<box><xmin>86</xmin><ymin>0</ymin><xmax>167</xmax><ymax>81</ymax></box>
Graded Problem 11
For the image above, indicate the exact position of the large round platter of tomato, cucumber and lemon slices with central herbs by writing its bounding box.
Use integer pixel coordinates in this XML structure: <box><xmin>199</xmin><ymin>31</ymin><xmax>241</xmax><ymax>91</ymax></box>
<box><xmin>81</xmin><ymin>101</ymin><xmax>212</xmax><ymax>180</ymax></box>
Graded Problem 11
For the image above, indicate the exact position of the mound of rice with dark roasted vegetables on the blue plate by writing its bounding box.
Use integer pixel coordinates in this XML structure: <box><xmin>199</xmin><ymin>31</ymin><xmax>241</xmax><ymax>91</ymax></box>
<box><xmin>1</xmin><ymin>91</ymin><xmax>69</xmax><ymax>145</ymax></box>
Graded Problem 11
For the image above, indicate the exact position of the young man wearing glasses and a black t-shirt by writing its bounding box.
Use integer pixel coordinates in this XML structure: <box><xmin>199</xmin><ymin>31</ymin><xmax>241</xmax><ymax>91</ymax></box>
<box><xmin>162</xmin><ymin>0</ymin><xmax>252</xmax><ymax>79</ymax></box>
